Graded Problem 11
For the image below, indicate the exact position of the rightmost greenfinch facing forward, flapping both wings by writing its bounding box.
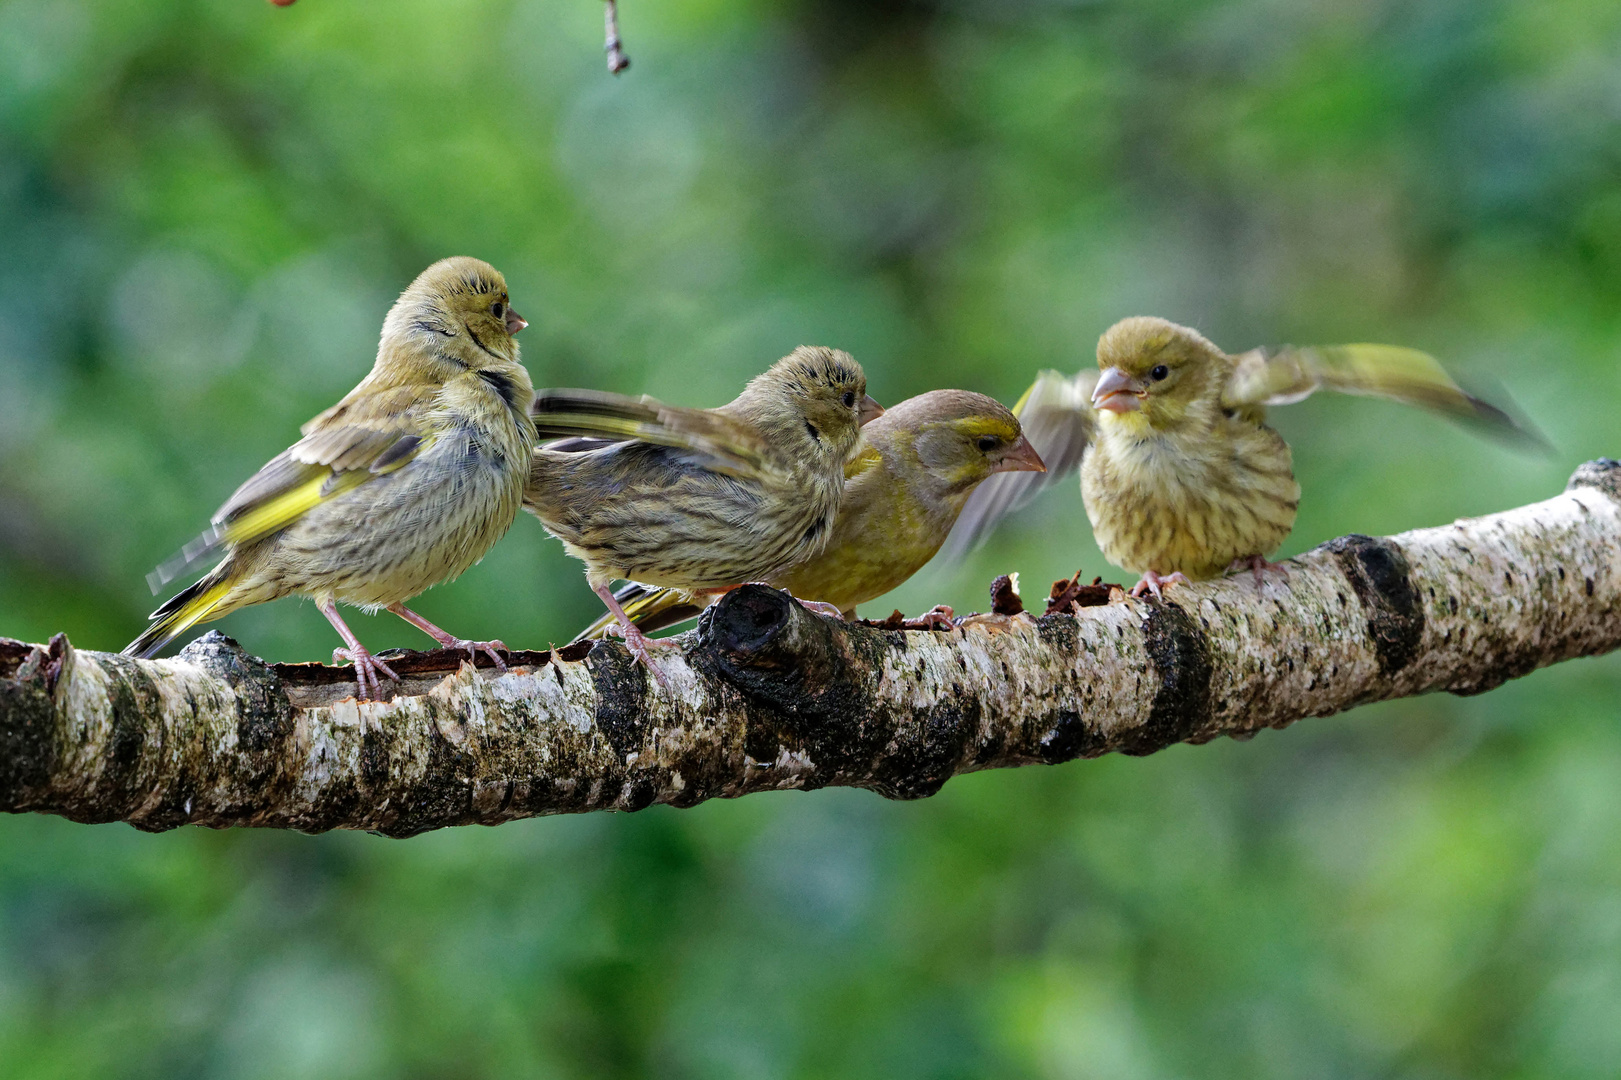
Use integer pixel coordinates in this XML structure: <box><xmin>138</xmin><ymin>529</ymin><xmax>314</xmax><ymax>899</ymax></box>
<box><xmin>952</xmin><ymin>316</ymin><xmax>1527</xmax><ymax>597</ymax></box>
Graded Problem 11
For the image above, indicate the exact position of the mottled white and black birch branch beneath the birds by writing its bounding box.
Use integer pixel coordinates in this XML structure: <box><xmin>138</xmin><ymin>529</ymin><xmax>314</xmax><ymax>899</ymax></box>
<box><xmin>0</xmin><ymin>461</ymin><xmax>1621</xmax><ymax>837</ymax></box>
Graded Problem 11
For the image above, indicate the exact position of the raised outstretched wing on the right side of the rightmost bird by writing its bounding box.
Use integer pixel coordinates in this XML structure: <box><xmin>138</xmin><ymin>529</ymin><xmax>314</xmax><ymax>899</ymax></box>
<box><xmin>1222</xmin><ymin>344</ymin><xmax>1542</xmax><ymax>441</ymax></box>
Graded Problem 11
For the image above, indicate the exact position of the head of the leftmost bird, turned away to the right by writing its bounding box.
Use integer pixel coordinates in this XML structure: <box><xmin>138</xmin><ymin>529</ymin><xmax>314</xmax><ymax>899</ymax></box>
<box><xmin>383</xmin><ymin>255</ymin><xmax>528</xmax><ymax>371</ymax></box>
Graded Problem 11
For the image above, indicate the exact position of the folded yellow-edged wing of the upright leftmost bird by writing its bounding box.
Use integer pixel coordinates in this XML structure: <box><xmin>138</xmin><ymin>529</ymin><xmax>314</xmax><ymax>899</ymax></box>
<box><xmin>148</xmin><ymin>388</ymin><xmax>433</xmax><ymax>592</ymax></box>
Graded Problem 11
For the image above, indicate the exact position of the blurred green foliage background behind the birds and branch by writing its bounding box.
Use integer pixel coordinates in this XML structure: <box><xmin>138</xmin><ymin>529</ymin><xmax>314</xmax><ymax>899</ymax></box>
<box><xmin>0</xmin><ymin>0</ymin><xmax>1621</xmax><ymax>1080</ymax></box>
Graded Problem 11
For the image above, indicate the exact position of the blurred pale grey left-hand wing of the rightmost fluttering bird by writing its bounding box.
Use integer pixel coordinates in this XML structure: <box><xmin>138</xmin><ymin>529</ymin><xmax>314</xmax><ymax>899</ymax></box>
<box><xmin>943</xmin><ymin>370</ymin><xmax>1097</xmax><ymax>561</ymax></box>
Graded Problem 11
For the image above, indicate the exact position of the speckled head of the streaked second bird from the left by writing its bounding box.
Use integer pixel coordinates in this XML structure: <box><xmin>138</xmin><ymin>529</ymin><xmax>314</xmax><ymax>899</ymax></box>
<box><xmin>734</xmin><ymin>345</ymin><xmax>883</xmax><ymax>462</ymax></box>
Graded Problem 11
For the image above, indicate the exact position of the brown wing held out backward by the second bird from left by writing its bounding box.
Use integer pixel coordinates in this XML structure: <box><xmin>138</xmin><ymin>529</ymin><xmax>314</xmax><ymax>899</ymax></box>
<box><xmin>532</xmin><ymin>389</ymin><xmax>772</xmax><ymax>474</ymax></box>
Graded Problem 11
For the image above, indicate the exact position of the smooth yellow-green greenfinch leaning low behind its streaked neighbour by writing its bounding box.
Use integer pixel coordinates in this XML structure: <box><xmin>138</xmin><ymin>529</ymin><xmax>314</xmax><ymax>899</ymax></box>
<box><xmin>580</xmin><ymin>391</ymin><xmax>1044</xmax><ymax>637</ymax></box>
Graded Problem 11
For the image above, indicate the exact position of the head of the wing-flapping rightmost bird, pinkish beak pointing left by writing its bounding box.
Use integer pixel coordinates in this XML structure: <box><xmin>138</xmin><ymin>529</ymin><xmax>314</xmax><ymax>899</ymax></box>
<box><xmin>1093</xmin><ymin>316</ymin><xmax>1232</xmax><ymax>430</ymax></box>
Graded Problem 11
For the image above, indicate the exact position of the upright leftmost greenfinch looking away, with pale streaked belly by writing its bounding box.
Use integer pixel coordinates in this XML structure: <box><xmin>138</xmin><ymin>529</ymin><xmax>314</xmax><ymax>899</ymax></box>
<box><xmin>125</xmin><ymin>258</ymin><xmax>535</xmax><ymax>699</ymax></box>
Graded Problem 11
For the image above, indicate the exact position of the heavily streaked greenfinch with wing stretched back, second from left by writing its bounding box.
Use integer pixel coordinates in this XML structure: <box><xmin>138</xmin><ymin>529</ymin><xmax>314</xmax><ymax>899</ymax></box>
<box><xmin>524</xmin><ymin>345</ymin><xmax>883</xmax><ymax>671</ymax></box>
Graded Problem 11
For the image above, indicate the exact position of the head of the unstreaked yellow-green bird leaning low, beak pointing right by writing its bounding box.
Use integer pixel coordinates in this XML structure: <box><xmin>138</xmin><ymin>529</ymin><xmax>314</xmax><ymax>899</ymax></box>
<box><xmin>888</xmin><ymin>389</ymin><xmax>1047</xmax><ymax>499</ymax></box>
